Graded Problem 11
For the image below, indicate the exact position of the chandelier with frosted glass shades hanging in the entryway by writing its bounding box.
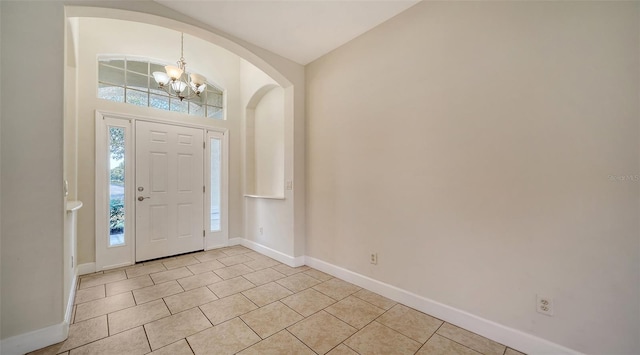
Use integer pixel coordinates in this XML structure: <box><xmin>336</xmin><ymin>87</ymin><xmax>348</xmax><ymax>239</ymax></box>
<box><xmin>153</xmin><ymin>33</ymin><xmax>207</xmax><ymax>101</ymax></box>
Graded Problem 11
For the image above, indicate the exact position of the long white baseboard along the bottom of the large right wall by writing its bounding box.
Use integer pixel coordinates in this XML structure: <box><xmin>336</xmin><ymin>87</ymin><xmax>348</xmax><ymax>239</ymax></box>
<box><xmin>305</xmin><ymin>256</ymin><xmax>581</xmax><ymax>355</ymax></box>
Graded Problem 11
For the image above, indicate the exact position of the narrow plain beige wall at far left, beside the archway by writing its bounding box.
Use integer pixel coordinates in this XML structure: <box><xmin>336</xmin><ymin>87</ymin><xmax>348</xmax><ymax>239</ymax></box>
<box><xmin>0</xmin><ymin>1</ymin><xmax>65</xmax><ymax>339</ymax></box>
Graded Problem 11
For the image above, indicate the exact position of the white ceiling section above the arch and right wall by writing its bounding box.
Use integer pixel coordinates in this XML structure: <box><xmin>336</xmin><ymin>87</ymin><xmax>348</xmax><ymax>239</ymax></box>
<box><xmin>154</xmin><ymin>0</ymin><xmax>418</xmax><ymax>65</ymax></box>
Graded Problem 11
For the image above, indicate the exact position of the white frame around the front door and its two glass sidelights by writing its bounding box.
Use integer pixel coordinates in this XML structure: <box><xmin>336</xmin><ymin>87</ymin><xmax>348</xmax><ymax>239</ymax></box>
<box><xmin>94</xmin><ymin>110</ymin><xmax>229</xmax><ymax>271</ymax></box>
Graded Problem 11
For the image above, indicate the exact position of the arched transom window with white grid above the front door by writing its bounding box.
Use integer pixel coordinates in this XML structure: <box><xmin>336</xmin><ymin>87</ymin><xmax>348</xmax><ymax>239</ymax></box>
<box><xmin>98</xmin><ymin>58</ymin><xmax>224</xmax><ymax>120</ymax></box>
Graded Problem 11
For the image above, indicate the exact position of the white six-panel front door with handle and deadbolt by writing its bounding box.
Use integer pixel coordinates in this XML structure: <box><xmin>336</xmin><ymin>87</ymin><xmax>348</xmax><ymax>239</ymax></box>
<box><xmin>135</xmin><ymin>121</ymin><xmax>204</xmax><ymax>262</ymax></box>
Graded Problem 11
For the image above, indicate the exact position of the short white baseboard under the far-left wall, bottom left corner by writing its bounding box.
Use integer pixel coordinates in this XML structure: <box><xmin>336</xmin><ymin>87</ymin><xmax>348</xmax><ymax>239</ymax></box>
<box><xmin>0</xmin><ymin>321</ymin><xmax>69</xmax><ymax>355</ymax></box>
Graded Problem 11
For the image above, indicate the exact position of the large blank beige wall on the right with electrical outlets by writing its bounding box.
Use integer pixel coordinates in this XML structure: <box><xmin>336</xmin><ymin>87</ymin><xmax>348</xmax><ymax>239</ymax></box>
<box><xmin>306</xmin><ymin>2</ymin><xmax>640</xmax><ymax>353</ymax></box>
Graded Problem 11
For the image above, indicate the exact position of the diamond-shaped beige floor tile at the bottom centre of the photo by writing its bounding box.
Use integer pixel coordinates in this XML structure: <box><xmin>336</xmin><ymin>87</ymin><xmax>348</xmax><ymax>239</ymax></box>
<box><xmin>288</xmin><ymin>311</ymin><xmax>357</xmax><ymax>354</ymax></box>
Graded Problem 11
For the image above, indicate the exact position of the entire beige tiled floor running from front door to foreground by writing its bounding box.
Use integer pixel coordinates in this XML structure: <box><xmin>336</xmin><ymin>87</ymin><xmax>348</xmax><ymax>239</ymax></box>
<box><xmin>32</xmin><ymin>246</ymin><xmax>520</xmax><ymax>355</ymax></box>
